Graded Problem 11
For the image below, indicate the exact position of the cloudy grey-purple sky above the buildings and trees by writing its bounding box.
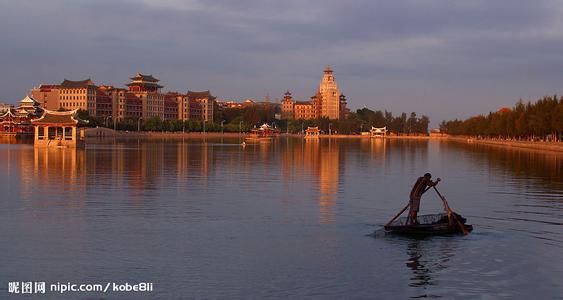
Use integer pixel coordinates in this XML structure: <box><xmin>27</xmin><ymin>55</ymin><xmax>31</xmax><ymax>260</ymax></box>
<box><xmin>0</xmin><ymin>0</ymin><xmax>563</xmax><ymax>125</ymax></box>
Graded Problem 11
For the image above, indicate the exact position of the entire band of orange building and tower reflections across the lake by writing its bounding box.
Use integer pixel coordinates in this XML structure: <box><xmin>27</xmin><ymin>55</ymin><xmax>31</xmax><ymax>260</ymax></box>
<box><xmin>14</xmin><ymin>138</ymin><xmax>418</xmax><ymax>224</ymax></box>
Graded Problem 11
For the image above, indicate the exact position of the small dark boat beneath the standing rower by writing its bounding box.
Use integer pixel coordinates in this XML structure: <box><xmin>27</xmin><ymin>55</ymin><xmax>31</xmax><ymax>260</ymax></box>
<box><xmin>384</xmin><ymin>213</ymin><xmax>473</xmax><ymax>235</ymax></box>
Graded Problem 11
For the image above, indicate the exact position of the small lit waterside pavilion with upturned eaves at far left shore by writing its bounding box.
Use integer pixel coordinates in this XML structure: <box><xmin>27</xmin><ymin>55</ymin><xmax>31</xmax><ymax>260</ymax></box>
<box><xmin>31</xmin><ymin>109</ymin><xmax>86</xmax><ymax>148</ymax></box>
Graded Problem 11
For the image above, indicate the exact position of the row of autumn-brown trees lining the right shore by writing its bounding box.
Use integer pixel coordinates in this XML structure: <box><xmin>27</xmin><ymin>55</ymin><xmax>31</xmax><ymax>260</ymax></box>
<box><xmin>440</xmin><ymin>95</ymin><xmax>563</xmax><ymax>141</ymax></box>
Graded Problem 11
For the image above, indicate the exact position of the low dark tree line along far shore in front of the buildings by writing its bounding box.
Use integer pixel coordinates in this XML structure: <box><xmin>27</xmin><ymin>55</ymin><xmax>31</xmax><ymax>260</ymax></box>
<box><xmin>79</xmin><ymin>105</ymin><xmax>430</xmax><ymax>134</ymax></box>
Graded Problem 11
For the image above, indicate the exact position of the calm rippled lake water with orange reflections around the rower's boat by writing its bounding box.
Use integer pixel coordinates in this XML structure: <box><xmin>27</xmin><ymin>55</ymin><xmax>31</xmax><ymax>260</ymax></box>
<box><xmin>0</xmin><ymin>138</ymin><xmax>563</xmax><ymax>299</ymax></box>
